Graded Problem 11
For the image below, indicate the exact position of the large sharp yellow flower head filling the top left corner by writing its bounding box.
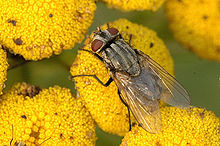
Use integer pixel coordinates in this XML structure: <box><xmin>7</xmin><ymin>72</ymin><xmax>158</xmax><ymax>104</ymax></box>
<box><xmin>0</xmin><ymin>0</ymin><xmax>96</xmax><ymax>60</ymax></box>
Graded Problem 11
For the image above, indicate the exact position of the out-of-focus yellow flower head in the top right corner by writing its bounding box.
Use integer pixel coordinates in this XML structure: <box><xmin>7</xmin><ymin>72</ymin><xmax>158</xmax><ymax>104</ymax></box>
<box><xmin>166</xmin><ymin>0</ymin><xmax>220</xmax><ymax>61</ymax></box>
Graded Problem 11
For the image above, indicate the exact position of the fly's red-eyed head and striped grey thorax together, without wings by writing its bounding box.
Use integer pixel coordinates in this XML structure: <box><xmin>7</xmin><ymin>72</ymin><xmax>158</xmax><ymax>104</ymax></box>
<box><xmin>91</xmin><ymin>28</ymin><xmax>140</xmax><ymax>76</ymax></box>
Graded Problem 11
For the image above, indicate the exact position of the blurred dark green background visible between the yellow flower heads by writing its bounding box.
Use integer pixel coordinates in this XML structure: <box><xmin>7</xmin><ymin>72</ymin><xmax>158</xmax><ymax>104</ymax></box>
<box><xmin>6</xmin><ymin>3</ymin><xmax>220</xmax><ymax>146</ymax></box>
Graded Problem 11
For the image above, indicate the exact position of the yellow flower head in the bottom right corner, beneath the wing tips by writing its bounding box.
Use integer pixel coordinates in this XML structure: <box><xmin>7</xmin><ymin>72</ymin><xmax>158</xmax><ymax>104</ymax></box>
<box><xmin>121</xmin><ymin>107</ymin><xmax>220</xmax><ymax>146</ymax></box>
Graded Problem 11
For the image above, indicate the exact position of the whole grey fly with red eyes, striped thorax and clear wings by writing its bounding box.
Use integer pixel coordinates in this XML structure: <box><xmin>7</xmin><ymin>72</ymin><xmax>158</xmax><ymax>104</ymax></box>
<box><xmin>73</xmin><ymin>26</ymin><xmax>190</xmax><ymax>133</ymax></box>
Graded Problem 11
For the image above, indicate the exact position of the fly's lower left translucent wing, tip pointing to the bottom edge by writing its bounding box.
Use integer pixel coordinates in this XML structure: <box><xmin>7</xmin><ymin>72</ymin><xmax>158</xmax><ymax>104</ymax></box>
<box><xmin>112</xmin><ymin>72</ymin><xmax>162</xmax><ymax>133</ymax></box>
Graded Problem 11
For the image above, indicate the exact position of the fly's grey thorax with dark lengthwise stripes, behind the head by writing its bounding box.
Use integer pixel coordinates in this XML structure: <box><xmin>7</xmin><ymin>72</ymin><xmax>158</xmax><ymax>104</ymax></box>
<box><xmin>102</xmin><ymin>39</ymin><xmax>140</xmax><ymax>76</ymax></box>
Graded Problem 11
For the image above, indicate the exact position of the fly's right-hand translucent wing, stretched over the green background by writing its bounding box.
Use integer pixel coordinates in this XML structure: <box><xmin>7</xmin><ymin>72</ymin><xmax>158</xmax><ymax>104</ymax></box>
<box><xmin>135</xmin><ymin>50</ymin><xmax>190</xmax><ymax>108</ymax></box>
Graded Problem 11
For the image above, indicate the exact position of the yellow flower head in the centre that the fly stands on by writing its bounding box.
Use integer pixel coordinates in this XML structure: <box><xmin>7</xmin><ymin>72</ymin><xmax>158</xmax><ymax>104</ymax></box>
<box><xmin>70</xmin><ymin>19</ymin><xmax>173</xmax><ymax>135</ymax></box>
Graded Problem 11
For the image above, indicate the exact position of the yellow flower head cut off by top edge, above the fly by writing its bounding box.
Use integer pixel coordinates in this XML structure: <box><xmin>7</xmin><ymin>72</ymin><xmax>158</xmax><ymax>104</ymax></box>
<box><xmin>102</xmin><ymin>0</ymin><xmax>165</xmax><ymax>11</ymax></box>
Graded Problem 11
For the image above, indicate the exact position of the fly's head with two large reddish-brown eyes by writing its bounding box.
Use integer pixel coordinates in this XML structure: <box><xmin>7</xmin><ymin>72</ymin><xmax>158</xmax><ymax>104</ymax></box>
<box><xmin>91</xmin><ymin>27</ymin><xmax>119</xmax><ymax>53</ymax></box>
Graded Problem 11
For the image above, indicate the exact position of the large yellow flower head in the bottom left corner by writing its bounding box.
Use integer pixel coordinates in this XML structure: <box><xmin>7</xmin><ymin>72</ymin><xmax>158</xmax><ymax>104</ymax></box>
<box><xmin>0</xmin><ymin>83</ymin><xmax>96</xmax><ymax>145</ymax></box>
